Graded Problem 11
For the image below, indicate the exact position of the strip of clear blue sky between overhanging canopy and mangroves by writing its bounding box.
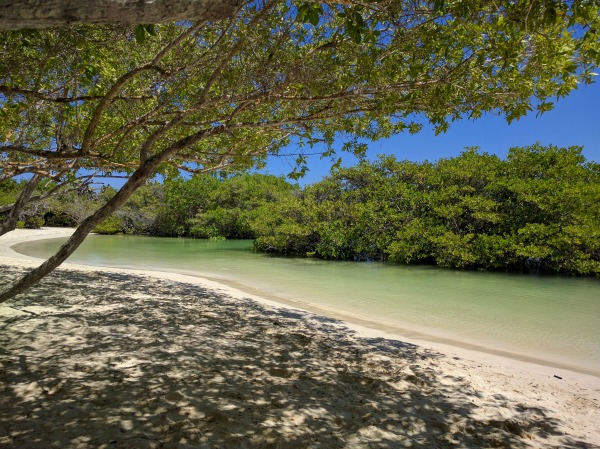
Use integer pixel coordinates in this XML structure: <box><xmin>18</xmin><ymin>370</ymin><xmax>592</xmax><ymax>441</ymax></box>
<box><xmin>261</xmin><ymin>77</ymin><xmax>600</xmax><ymax>185</ymax></box>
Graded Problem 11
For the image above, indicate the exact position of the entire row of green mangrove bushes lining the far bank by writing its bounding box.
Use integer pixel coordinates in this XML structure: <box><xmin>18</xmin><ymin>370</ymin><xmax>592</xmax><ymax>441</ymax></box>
<box><xmin>0</xmin><ymin>145</ymin><xmax>600</xmax><ymax>275</ymax></box>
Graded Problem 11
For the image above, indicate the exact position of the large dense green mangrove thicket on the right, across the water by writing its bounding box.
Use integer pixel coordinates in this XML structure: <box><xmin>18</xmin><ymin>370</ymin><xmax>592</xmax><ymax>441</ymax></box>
<box><xmin>255</xmin><ymin>145</ymin><xmax>600</xmax><ymax>275</ymax></box>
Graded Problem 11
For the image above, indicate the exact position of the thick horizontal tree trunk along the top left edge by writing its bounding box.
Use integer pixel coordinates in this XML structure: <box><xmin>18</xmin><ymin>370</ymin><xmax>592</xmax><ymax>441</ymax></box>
<box><xmin>0</xmin><ymin>0</ymin><xmax>242</xmax><ymax>31</ymax></box>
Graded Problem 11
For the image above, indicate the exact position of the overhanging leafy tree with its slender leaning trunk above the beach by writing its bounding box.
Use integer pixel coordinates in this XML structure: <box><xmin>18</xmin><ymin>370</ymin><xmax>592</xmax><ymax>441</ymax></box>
<box><xmin>0</xmin><ymin>0</ymin><xmax>600</xmax><ymax>300</ymax></box>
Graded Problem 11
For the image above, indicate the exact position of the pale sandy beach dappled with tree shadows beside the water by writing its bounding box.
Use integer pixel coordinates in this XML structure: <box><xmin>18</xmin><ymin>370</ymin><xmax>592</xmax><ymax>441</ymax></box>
<box><xmin>0</xmin><ymin>229</ymin><xmax>600</xmax><ymax>449</ymax></box>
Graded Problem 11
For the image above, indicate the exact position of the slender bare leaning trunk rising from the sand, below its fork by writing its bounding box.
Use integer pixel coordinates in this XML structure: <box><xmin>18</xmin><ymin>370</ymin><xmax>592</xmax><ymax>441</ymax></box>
<box><xmin>0</xmin><ymin>153</ymin><xmax>166</xmax><ymax>304</ymax></box>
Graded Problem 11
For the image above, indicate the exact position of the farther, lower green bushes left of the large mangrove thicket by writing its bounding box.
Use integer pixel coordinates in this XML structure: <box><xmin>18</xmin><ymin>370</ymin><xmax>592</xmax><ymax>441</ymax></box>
<box><xmin>33</xmin><ymin>174</ymin><xmax>297</xmax><ymax>239</ymax></box>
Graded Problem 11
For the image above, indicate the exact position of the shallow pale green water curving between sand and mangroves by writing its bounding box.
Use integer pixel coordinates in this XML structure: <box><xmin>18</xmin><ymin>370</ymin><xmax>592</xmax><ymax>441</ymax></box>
<box><xmin>15</xmin><ymin>235</ymin><xmax>600</xmax><ymax>375</ymax></box>
